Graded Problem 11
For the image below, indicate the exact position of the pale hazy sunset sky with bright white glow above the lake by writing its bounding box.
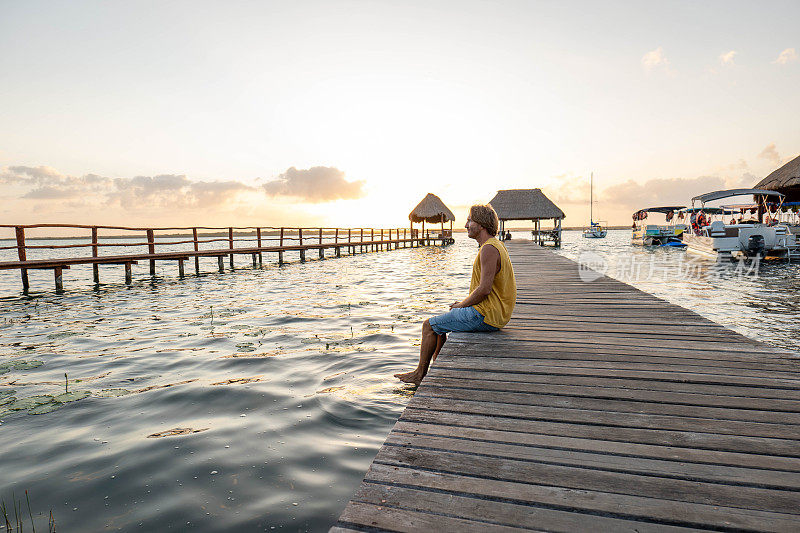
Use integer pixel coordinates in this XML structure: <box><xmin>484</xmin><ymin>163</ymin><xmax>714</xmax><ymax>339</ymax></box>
<box><xmin>0</xmin><ymin>0</ymin><xmax>800</xmax><ymax>232</ymax></box>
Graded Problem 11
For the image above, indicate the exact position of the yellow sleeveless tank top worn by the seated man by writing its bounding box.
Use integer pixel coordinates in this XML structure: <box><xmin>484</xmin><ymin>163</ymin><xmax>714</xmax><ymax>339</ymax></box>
<box><xmin>469</xmin><ymin>237</ymin><xmax>517</xmax><ymax>328</ymax></box>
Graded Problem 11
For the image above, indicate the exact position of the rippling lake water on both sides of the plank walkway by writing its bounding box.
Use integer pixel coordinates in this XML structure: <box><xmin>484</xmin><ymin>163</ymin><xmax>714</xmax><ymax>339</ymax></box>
<box><xmin>0</xmin><ymin>231</ymin><xmax>800</xmax><ymax>532</ymax></box>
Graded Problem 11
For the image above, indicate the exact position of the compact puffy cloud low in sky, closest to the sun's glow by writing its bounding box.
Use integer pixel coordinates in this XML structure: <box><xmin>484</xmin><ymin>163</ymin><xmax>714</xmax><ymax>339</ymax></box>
<box><xmin>263</xmin><ymin>167</ymin><xmax>365</xmax><ymax>203</ymax></box>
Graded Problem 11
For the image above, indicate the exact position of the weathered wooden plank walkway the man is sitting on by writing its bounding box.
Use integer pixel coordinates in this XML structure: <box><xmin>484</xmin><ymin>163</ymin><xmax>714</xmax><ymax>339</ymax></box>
<box><xmin>331</xmin><ymin>241</ymin><xmax>800</xmax><ymax>532</ymax></box>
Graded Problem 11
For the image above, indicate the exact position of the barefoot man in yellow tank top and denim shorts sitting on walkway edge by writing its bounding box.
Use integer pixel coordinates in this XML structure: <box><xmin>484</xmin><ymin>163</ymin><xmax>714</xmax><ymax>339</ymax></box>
<box><xmin>395</xmin><ymin>205</ymin><xmax>517</xmax><ymax>385</ymax></box>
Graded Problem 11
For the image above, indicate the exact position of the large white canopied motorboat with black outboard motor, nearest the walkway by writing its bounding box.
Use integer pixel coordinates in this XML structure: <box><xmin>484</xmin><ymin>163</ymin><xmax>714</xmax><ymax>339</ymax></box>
<box><xmin>683</xmin><ymin>189</ymin><xmax>798</xmax><ymax>261</ymax></box>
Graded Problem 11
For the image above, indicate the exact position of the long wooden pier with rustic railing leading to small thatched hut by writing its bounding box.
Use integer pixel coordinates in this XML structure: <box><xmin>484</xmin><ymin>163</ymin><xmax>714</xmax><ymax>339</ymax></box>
<box><xmin>0</xmin><ymin>224</ymin><xmax>453</xmax><ymax>294</ymax></box>
